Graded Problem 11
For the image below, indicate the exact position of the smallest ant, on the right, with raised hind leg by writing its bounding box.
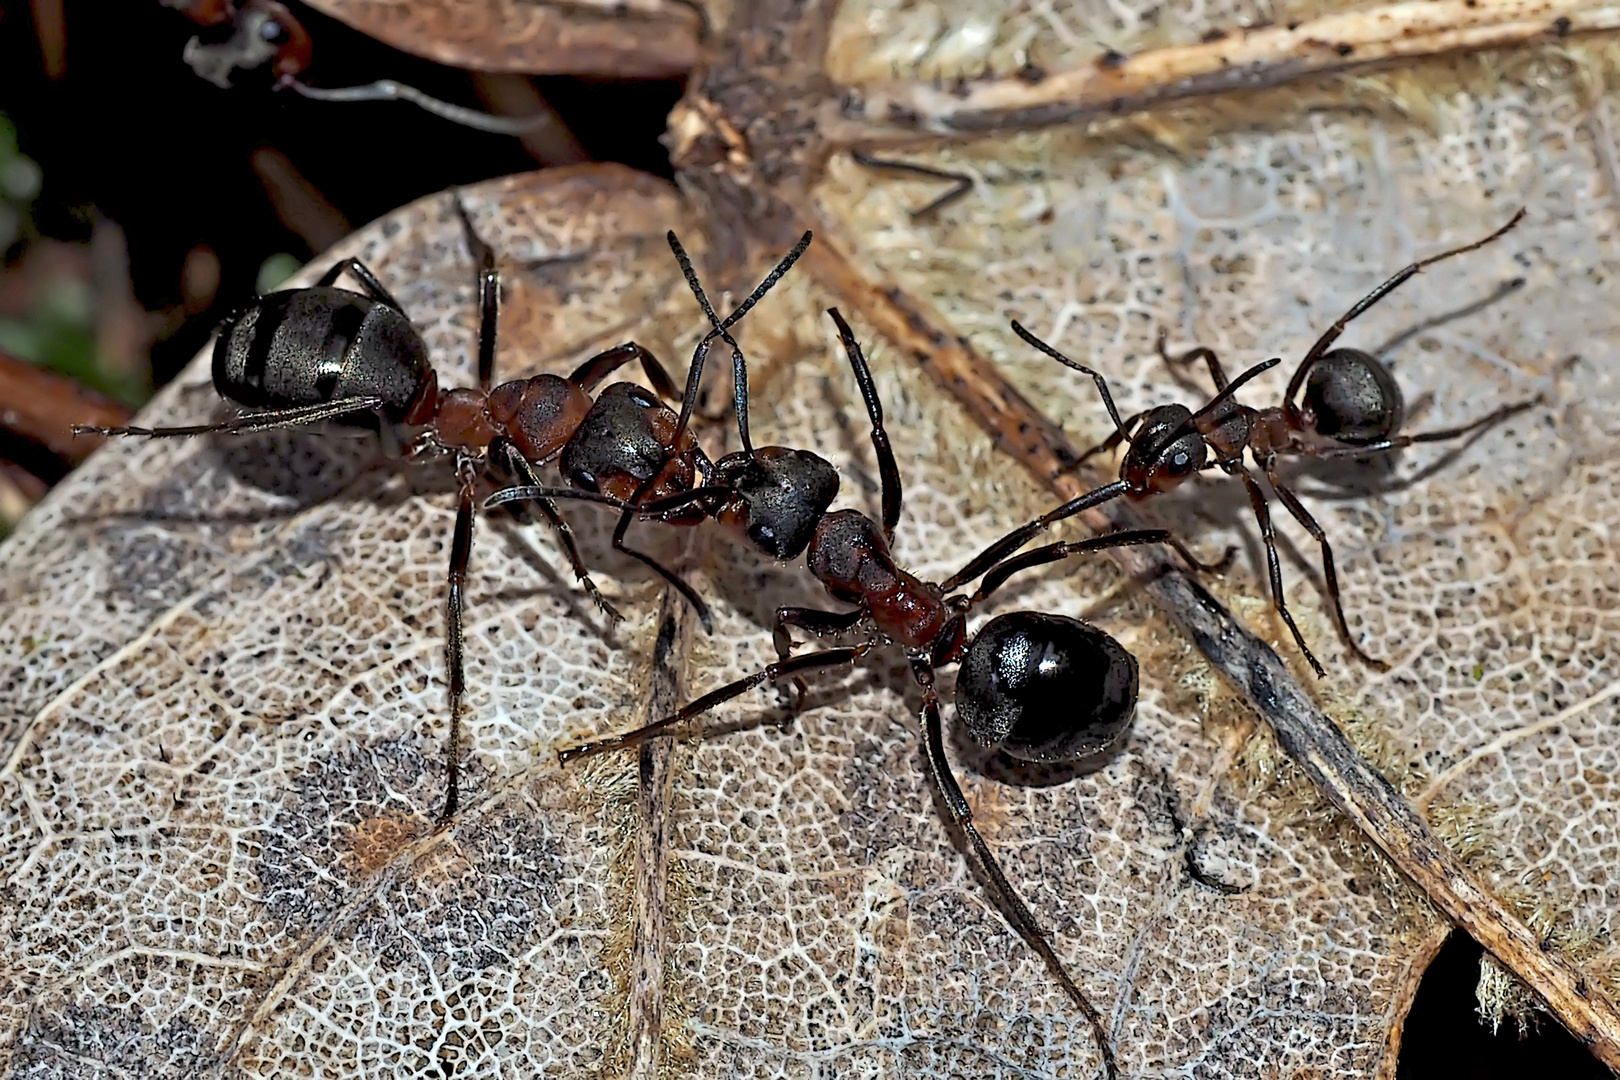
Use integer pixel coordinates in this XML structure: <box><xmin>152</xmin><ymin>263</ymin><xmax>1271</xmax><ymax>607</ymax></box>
<box><xmin>970</xmin><ymin>209</ymin><xmax>1542</xmax><ymax>677</ymax></box>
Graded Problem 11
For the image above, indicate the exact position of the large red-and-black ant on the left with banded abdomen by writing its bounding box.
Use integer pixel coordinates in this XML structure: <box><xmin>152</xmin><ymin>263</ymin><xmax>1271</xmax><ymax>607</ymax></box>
<box><xmin>73</xmin><ymin>194</ymin><xmax>810</xmax><ymax>826</ymax></box>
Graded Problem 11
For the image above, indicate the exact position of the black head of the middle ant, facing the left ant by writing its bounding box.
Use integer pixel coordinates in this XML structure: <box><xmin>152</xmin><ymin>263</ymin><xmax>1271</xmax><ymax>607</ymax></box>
<box><xmin>714</xmin><ymin>447</ymin><xmax>838</xmax><ymax>560</ymax></box>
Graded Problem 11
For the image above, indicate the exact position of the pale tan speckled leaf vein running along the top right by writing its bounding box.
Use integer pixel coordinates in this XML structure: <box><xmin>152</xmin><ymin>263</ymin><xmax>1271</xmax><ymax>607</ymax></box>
<box><xmin>828</xmin><ymin>0</ymin><xmax>1620</xmax><ymax>137</ymax></box>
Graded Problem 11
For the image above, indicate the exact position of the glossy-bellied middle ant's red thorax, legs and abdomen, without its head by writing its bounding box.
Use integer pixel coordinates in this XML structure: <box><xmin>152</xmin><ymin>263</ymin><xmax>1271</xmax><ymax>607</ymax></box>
<box><xmin>557</xmin><ymin>308</ymin><xmax>1170</xmax><ymax>1077</ymax></box>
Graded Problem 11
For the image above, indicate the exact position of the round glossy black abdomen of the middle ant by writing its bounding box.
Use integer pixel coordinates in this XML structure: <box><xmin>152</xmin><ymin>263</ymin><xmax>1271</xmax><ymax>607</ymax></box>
<box><xmin>956</xmin><ymin>612</ymin><xmax>1137</xmax><ymax>763</ymax></box>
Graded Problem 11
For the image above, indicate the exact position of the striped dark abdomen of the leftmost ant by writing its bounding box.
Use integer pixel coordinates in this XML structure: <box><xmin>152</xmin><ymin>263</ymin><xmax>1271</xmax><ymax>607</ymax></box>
<box><xmin>214</xmin><ymin>287</ymin><xmax>433</xmax><ymax>424</ymax></box>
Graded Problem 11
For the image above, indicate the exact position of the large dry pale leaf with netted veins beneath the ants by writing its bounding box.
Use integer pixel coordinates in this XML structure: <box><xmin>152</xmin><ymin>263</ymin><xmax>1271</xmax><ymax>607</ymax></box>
<box><xmin>0</xmin><ymin>5</ymin><xmax>1620</xmax><ymax>1077</ymax></box>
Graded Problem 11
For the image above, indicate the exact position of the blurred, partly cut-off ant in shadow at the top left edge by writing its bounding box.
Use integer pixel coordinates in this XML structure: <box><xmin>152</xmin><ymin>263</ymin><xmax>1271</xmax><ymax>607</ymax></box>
<box><xmin>164</xmin><ymin>0</ymin><xmax>552</xmax><ymax>134</ymax></box>
